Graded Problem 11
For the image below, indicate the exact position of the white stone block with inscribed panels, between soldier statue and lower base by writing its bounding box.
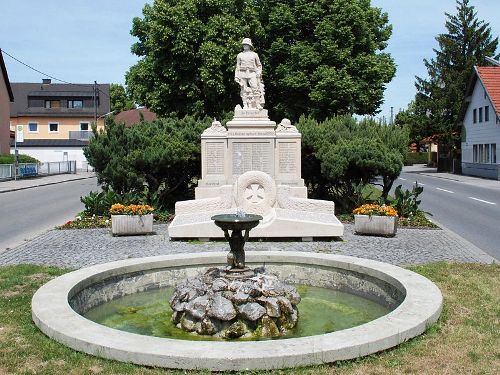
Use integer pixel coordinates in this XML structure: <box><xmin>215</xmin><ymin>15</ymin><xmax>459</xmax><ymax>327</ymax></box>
<box><xmin>195</xmin><ymin>106</ymin><xmax>307</xmax><ymax>199</ymax></box>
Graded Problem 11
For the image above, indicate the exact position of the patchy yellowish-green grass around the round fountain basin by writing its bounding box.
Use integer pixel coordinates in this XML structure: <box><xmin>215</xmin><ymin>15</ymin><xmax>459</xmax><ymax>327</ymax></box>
<box><xmin>0</xmin><ymin>263</ymin><xmax>500</xmax><ymax>375</ymax></box>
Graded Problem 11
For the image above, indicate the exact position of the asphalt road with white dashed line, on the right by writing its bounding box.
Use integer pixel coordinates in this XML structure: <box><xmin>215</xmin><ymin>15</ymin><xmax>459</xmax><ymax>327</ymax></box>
<box><xmin>394</xmin><ymin>172</ymin><xmax>500</xmax><ymax>260</ymax></box>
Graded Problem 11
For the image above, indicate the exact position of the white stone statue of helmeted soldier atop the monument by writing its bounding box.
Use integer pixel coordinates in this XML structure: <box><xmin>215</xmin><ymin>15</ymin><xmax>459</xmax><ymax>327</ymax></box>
<box><xmin>234</xmin><ymin>38</ymin><xmax>265</xmax><ymax>110</ymax></box>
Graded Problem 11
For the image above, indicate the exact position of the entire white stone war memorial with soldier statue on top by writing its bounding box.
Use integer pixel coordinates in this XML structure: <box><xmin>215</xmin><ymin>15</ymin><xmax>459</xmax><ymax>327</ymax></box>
<box><xmin>169</xmin><ymin>38</ymin><xmax>344</xmax><ymax>240</ymax></box>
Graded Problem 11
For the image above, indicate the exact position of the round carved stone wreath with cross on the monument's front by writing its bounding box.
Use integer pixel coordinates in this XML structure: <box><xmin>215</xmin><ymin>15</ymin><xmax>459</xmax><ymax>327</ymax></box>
<box><xmin>234</xmin><ymin>171</ymin><xmax>276</xmax><ymax>215</ymax></box>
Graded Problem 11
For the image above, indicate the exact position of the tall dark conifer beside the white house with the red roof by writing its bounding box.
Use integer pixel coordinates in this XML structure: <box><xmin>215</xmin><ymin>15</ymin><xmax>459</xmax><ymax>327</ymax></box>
<box><xmin>415</xmin><ymin>0</ymin><xmax>498</xmax><ymax>168</ymax></box>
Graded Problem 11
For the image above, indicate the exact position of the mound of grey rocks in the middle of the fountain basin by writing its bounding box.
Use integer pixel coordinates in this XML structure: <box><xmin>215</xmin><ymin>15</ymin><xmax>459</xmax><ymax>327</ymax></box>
<box><xmin>170</xmin><ymin>268</ymin><xmax>300</xmax><ymax>339</ymax></box>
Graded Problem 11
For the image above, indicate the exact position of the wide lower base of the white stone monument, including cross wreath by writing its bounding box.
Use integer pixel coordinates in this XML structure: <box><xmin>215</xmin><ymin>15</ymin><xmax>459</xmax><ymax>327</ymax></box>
<box><xmin>168</xmin><ymin>171</ymin><xmax>344</xmax><ymax>238</ymax></box>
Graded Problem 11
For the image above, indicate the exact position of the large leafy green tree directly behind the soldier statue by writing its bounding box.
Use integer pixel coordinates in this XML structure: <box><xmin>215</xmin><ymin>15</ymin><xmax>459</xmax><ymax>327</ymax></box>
<box><xmin>126</xmin><ymin>0</ymin><xmax>395</xmax><ymax>120</ymax></box>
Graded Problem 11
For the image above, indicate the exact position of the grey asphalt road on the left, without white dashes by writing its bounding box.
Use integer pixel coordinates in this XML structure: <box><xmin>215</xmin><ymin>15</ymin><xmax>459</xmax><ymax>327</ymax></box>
<box><xmin>0</xmin><ymin>178</ymin><xmax>98</xmax><ymax>252</ymax></box>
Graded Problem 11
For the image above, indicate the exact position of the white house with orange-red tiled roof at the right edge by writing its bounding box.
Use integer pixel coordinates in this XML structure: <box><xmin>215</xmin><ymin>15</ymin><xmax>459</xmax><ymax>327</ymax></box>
<box><xmin>462</xmin><ymin>66</ymin><xmax>500</xmax><ymax>180</ymax></box>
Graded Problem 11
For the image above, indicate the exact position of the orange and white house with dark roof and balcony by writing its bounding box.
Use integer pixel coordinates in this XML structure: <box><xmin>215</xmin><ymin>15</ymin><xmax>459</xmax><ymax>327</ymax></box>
<box><xmin>10</xmin><ymin>79</ymin><xmax>110</xmax><ymax>168</ymax></box>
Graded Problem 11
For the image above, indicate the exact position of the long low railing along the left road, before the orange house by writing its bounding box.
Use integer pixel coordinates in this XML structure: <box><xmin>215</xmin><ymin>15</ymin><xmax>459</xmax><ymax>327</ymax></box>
<box><xmin>0</xmin><ymin>160</ymin><xmax>76</xmax><ymax>180</ymax></box>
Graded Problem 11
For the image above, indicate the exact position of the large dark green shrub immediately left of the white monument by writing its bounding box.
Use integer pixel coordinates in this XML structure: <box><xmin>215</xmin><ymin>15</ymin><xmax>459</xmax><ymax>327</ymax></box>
<box><xmin>84</xmin><ymin>116</ymin><xmax>212</xmax><ymax>210</ymax></box>
